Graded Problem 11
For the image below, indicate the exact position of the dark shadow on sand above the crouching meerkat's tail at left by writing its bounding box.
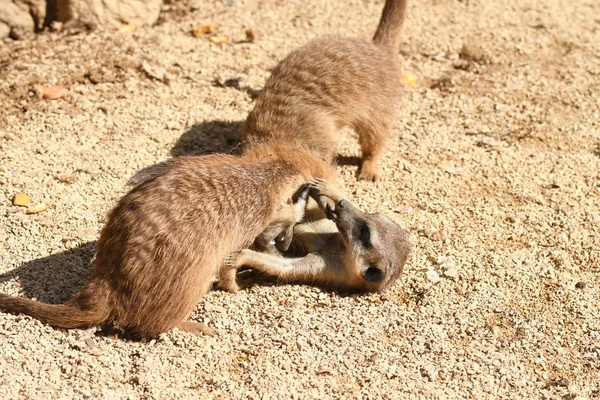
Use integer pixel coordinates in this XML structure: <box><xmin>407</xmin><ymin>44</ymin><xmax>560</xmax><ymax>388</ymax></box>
<box><xmin>0</xmin><ymin>241</ymin><xmax>96</xmax><ymax>304</ymax></box>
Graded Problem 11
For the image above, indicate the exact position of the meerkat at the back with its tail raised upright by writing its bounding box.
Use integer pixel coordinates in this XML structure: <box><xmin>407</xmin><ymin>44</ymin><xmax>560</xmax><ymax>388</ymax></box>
<box><xmin>241</xmin><ymin>0</ymin><xmax>406</xmax><ymax>181</ymax></box>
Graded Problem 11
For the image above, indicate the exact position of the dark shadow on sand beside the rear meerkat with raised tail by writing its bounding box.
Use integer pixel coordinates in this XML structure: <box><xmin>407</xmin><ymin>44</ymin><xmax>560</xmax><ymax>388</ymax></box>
<box><xmin>171</xmin><ymin>120</ymin><xmax>243</xmax><ymax>157</ymax></box>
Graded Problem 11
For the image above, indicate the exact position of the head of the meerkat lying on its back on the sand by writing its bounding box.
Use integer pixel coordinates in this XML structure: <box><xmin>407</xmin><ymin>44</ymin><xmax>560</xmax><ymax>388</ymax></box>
<box><xmin>326</xmin><ymin>200</ymin><xmax>411</xmax><ymax>291</ymax></box>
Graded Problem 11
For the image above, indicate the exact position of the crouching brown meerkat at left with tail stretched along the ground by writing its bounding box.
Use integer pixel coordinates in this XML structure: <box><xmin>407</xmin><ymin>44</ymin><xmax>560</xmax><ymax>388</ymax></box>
<box><xmin>0</xmin><ymin>146</ymin><xmax>334</xmax><ymax>337</ymax></box>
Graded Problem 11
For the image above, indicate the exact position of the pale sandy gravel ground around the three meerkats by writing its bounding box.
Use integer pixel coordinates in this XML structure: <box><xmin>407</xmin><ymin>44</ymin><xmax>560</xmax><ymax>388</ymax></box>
<box><xmin>0</xmin><ymin>0</ymin><xmax>600</xmax><ymax>399</ymax></box>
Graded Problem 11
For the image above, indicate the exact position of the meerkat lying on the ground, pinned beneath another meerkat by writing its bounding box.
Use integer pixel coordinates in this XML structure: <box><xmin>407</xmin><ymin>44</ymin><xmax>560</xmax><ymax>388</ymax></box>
<box><xmin>227</xmin><ymin>180</ymin><xmax>411</xmax><ymax>292</ymax></box>
